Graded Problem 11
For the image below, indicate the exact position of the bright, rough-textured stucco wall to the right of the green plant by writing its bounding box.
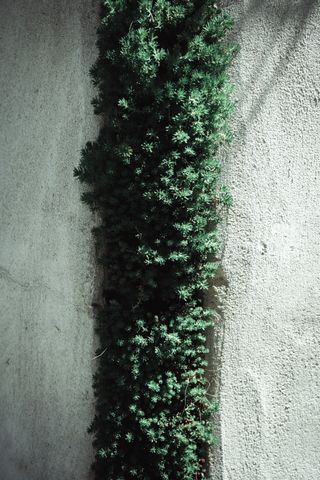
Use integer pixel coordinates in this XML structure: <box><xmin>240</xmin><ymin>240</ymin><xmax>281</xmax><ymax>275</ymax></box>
<box><xmin>212</xmin><ymin>0</ymin><xmax>320</xmax><ymax>480</ymax></box>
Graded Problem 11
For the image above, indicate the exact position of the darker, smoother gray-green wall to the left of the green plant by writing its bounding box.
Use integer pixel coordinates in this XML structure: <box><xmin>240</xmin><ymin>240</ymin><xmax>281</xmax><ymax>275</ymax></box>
<box><xmin>0</xmin><ymin>0</ymin><xmax>97</xmax><ymax>480</ymax></box>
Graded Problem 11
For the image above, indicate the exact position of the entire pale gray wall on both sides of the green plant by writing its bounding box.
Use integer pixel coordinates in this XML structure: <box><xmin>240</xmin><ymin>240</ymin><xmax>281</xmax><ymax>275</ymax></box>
<box><xmin>0</xmin><ymin>0</ymin><xmax>320</xmax><ymax>480</ymax></box>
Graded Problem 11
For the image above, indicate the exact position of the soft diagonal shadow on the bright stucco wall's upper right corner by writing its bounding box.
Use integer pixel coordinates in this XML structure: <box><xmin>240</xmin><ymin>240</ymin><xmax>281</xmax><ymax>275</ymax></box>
<box><xmin>224</xmin><ymin>0</ymin><xmax>318</xmax><ymax>141</ymax></box>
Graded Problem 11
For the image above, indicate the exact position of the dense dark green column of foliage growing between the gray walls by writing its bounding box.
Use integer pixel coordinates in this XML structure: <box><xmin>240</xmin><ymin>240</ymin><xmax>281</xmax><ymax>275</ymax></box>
<box><xmin>75</xmin><ymin>0</ymin><xmax>235</xmax><ymax>480</ymax></box>
